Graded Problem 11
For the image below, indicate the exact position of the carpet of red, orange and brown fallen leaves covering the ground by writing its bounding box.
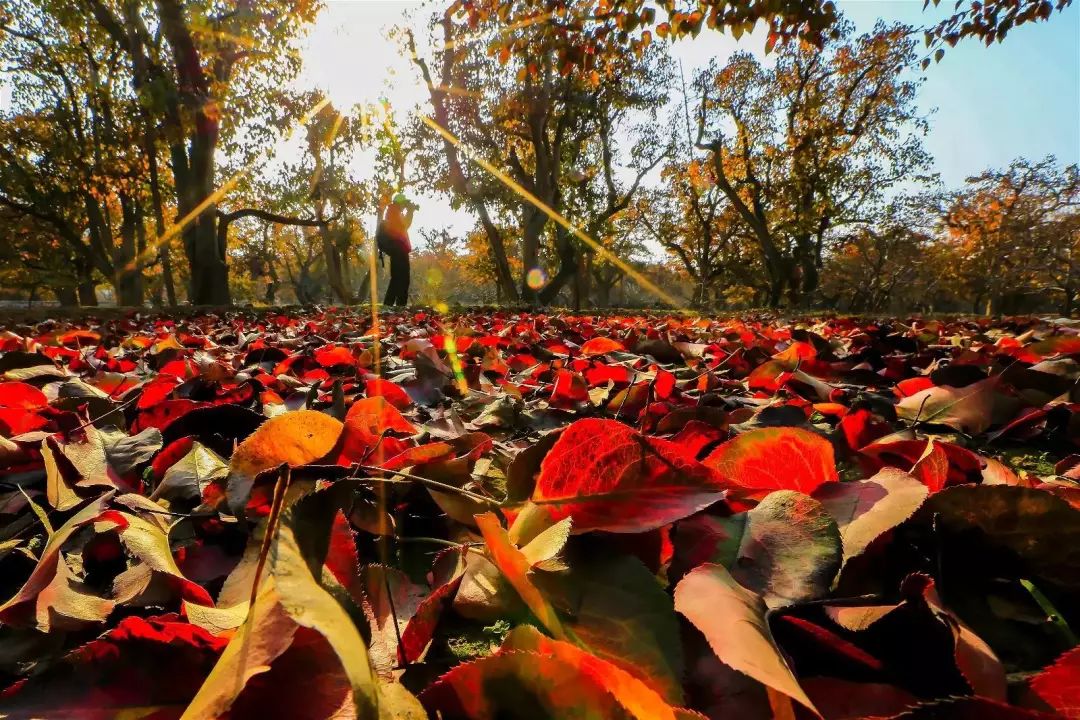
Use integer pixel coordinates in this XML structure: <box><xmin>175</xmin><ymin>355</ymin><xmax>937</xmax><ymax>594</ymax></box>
<box><xmin>0</xmin><ymin>309</ymin><xmax>1080</xmax><ymax>720</ymax></box>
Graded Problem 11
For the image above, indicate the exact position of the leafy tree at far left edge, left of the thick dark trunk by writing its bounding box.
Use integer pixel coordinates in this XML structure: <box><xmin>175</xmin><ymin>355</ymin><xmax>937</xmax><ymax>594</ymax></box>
<box><xmin>0</xmin><ymin>1</ymin><xmax>156</xmax><ymax>305</ymax></box>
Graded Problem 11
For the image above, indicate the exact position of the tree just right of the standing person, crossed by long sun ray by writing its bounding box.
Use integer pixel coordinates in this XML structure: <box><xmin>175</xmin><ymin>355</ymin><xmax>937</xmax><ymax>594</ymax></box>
<box><xmin>408</xmin><ymin>0</ymin><xmax>671</xmax><ymax>303</ymax></box>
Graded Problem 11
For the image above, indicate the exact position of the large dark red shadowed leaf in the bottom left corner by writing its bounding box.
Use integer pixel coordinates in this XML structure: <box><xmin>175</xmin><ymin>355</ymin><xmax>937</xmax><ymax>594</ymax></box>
<box><xmin>0</xmin><ymin>614</ymin><xmax>228</xmax><ymax>720</ymax></box>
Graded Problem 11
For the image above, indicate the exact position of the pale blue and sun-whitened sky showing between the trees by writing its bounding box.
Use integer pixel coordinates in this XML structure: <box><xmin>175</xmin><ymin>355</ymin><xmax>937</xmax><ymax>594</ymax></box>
<box><xmin>298</xmin><ymin>0</ymin><xmax>1080</xmax><ymax>243</ymax></box>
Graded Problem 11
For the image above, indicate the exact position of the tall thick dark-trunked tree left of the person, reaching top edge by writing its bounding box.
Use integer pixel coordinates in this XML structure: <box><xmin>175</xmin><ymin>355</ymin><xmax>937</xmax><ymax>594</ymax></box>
<box><xmin>86</xmin><ymin>0</ymin><xmax>320</xmax><ymax>304</ymax></box>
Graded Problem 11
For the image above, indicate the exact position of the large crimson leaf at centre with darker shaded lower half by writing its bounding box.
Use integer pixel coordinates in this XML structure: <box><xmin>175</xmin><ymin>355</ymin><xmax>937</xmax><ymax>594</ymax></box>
<box><xmin>530</xmin><ymin>418</ymin><xmax>727</xmax><ymax>532</ymax></box>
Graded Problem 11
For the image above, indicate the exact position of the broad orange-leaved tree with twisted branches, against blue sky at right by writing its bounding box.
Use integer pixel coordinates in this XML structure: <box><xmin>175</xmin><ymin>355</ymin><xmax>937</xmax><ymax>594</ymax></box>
<box><xmin>694</xmin><ymin>19</ymin><xmax>929</xmax><ymax>305</ymax></box>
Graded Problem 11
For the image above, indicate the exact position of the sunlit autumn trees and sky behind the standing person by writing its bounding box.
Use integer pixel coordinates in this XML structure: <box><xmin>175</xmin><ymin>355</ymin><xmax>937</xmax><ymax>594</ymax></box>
<box><xmin>0</xmin><ymin>0</ymin><xmax>1080</xmax><ymax>314</ymax></box>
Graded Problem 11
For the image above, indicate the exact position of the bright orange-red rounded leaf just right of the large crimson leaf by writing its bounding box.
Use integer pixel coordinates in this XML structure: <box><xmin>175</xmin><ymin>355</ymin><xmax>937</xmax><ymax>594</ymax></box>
<box><xmin>703</xmin><ymin>427</ymin><xmax>839</xmax><ymax>494</ymax></box>
